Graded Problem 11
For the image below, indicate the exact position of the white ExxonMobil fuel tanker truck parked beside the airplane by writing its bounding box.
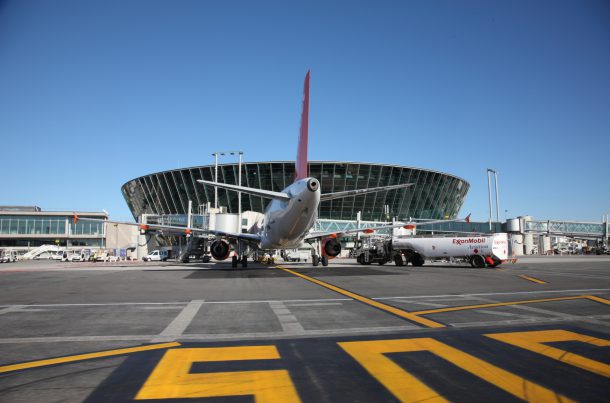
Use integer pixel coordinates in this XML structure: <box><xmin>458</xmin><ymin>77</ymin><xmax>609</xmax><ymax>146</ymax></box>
<box><xmin>356</xmin><ymin>233</ymin><xmax>508</xmax><ymax>268</ymax></box>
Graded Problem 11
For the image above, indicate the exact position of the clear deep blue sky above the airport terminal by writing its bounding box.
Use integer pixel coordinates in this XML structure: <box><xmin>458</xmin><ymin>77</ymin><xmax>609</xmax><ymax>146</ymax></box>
<box><xmin>0</xmin><ymin>0</ymin><xmax>610</xmax><ymax>221</ymax></box>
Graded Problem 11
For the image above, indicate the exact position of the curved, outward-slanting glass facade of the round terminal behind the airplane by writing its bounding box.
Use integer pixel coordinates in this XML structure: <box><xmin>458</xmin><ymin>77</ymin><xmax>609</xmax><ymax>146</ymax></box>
<box><xmin>121</xmin><ymin>161</ymin><xmax>470</xmax><ymax>221</ymax></box>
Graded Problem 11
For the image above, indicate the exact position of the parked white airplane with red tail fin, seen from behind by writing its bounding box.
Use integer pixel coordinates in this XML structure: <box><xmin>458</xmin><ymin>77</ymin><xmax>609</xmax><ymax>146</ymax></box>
<box><xmin>74</xmin><ymin>71</ymin><xmax>468</xmax><ymax>267</ymax></box>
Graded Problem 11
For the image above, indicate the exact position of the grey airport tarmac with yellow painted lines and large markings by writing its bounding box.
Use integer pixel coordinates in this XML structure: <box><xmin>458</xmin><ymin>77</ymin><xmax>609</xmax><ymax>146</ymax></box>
<box><xmin>0</xmin><ymin>256</ymin><xmax>610</xmax><ymax>403</ymax></box>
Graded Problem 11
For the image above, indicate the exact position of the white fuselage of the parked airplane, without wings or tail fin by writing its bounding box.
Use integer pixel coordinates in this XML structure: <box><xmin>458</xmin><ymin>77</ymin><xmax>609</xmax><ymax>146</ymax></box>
<box><xmin>260</xmin><ymin>178</ymin><xmax>320</xmax><ymax>249</ymax></box>
